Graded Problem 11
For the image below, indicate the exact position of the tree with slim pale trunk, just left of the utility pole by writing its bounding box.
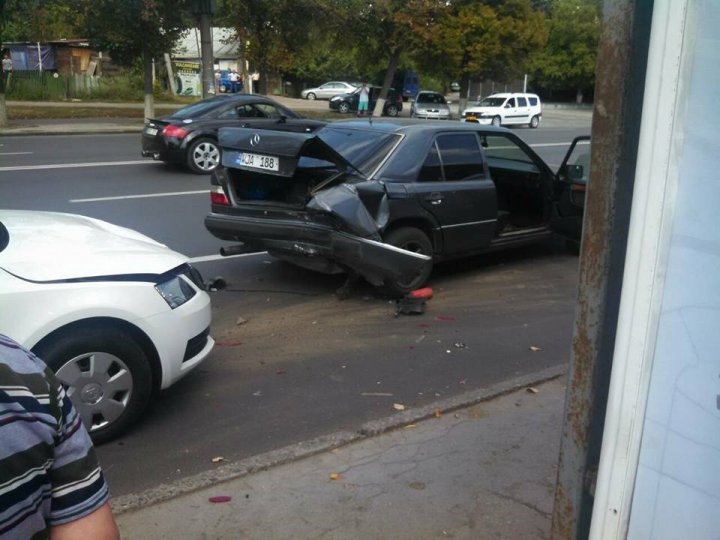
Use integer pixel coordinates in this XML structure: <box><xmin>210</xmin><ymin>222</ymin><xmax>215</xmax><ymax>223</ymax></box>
<box><xmin>82</xmin><ymin>0</ymin><xmax>192</xmax><ymax>118</ymax></box>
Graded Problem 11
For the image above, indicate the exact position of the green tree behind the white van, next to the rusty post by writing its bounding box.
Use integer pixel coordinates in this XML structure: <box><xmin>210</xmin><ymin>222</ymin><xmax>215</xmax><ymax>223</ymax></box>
<box><xmin>533</xmin><ymin>0</ymin><xmax>601</xmax><ymax>103</ymax></box>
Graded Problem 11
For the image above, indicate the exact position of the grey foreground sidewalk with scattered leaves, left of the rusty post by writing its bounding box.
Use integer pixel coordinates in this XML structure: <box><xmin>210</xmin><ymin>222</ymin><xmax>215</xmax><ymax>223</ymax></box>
<box><xmin>113</xmin><ymin>376</ymin><xmax>565</xmax><ymax>540</ymax></box>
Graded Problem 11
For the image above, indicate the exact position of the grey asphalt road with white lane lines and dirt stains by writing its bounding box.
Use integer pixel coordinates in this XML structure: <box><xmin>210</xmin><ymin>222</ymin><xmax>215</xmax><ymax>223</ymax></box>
<box><xmin>0</xmin><ymin>122</ymin><xmax>589</xmax><ymax>495</ymax></box>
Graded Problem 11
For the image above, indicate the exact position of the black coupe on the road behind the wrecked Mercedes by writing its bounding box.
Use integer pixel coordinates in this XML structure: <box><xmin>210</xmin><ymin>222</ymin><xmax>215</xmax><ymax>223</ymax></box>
<box><xmin>142</xmin><ymin>94</ymin><xmax>324</xmax><ymax>174</ymax></box>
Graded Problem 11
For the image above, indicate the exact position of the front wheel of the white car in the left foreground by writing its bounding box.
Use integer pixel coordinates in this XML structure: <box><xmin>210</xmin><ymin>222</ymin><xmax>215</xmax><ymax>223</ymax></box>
<box><xmin>34</xmin><ymin>326</ymin><xmax>153</xmax><ymax>444</ymax></box>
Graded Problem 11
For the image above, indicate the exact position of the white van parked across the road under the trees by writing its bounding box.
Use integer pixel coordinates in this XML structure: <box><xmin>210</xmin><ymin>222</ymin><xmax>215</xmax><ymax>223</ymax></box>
<box><xmin>462</xmin><ymin>93</ymin><xmax>542</xmax><ymax>128</ymax></box>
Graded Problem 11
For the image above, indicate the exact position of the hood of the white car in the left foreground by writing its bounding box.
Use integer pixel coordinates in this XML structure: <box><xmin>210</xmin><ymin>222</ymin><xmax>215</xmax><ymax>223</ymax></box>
<box><xmin>0</xmin><ymin>210</ymin><xmax>188</xmax><ymax>281</ymax></box>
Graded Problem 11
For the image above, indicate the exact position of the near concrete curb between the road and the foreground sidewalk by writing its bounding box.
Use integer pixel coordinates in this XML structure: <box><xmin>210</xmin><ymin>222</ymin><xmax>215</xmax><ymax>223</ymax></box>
<box><xmin>110</xmin><ymin>364</ymin><xmax>567</xmax><ymax>516</ymax></box>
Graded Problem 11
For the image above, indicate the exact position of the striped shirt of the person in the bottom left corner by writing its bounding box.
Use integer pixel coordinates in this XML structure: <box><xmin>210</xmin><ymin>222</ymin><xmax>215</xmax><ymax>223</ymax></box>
<box><xmin>0</xmin><ymin>334</ymin><xmax>108</xmax><ymax>540</ymax></box>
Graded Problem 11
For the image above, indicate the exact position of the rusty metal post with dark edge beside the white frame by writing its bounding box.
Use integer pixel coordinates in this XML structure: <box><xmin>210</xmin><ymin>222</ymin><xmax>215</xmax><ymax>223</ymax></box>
<box><xmin>552</xmin><ymin>0</ymin><xmax>653</xmax><ymax>540</ymax></box>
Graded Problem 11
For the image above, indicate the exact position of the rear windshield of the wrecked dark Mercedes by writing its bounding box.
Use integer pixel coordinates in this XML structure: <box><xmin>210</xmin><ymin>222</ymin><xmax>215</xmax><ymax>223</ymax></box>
<box><xmin>318</xmin><ymin>127</ymin><xmax>400</xmax><ymax>176</ymax></box>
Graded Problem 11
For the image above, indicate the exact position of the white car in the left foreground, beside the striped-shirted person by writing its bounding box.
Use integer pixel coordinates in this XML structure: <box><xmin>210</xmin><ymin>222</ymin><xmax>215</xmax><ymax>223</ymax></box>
<box><xmin>0</xmin><ymin>210</ymin><xmax>215</xmax><ymax>442</ymax></box>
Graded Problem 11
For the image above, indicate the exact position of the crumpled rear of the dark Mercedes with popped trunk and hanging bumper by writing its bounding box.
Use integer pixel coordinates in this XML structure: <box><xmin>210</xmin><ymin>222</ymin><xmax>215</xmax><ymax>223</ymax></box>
<box><xmin>211</xmin><ymin>128</ymin><xmax>431</xmax><ymax>285</ymax></box>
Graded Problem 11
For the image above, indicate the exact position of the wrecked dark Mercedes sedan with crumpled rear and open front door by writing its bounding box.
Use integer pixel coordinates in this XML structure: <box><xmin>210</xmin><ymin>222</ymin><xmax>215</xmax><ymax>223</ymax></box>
<box><xmin>205</xmin><ymin>121</ymin><xmax>589</xmax><ymax>296</ymax></box>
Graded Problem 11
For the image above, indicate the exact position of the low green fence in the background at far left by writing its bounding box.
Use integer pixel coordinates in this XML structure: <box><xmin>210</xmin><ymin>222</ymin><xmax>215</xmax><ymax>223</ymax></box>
<box><xmin>5</xmin><ymin>70</ymin><xmax>143</xmax><ymax>101</ymax></box>
